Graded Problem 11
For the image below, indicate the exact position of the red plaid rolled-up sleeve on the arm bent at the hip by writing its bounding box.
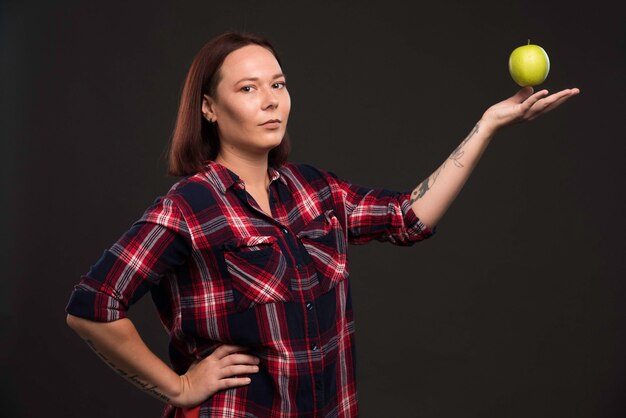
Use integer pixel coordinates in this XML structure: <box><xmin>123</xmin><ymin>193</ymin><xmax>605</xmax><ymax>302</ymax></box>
<box><xmin>66</xmin><ymin>197</ymin><xmax>191</xmax><ymax>322</ymax></box>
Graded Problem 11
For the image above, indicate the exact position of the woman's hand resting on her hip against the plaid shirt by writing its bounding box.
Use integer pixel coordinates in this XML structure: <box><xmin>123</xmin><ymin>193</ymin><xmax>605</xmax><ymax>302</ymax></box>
<box><xmin>170</xmin><ymin>344</ymin><xmax>260</xmax><ymax>408</ymax></box>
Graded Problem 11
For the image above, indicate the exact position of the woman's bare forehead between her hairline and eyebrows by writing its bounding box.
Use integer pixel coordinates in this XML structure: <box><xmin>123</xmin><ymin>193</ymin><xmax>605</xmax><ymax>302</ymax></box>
<box><xmin>221</xmin><ymin>45</ymin><xmax>281</xmax><ymax>82</ymax></box>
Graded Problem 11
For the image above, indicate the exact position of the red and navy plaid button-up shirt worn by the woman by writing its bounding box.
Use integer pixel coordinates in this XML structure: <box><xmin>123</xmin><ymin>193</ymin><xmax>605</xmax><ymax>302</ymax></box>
<box><xmin>67</xmin><ymin>161</ymin><xmax>432</xmax><ymax>418</ymax></box>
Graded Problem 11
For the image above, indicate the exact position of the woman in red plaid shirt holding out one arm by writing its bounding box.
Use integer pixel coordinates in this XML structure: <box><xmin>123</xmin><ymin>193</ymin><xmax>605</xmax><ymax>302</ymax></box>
<box><xmin>67</xmin><ymin>33</ymin><xmax>579</xmax><ymax>417</ymax></box>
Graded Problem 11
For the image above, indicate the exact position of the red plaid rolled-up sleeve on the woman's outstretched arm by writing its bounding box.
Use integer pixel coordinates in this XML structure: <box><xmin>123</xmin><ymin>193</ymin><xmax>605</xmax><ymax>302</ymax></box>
<box><xmin>328</xmin><ymin>172</ymin><xmax>435</xmax><ymax>246</ymax></box>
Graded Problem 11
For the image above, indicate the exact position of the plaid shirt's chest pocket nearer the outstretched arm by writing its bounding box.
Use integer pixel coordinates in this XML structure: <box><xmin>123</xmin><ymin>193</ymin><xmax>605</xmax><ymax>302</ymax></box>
<box><xmin>297</xmin><ymin>209</ymin><xmax>349</xmax><ymax>291</ymax></box>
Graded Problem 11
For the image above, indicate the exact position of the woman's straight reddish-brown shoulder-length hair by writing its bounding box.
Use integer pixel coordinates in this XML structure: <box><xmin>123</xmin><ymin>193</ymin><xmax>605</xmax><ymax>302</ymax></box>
<box><xmin>167</xmin><ymin>32</ymin><xmax>290</xmax><ymax>176</ymax></box>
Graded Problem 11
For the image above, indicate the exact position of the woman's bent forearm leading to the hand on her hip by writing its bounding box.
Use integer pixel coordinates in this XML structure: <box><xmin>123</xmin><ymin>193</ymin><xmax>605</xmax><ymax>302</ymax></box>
<box><xmin>67</xmin><ymin>315</ymin><xmax>181</xmax><ymax>402</ymax></box>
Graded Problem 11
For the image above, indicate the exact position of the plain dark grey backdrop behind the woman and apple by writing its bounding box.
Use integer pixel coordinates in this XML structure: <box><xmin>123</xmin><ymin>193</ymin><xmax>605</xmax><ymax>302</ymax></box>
<box><xmin>0</xmin><ymin>0</ymin><xmax>626</xmax><ymax>417</ymax></box>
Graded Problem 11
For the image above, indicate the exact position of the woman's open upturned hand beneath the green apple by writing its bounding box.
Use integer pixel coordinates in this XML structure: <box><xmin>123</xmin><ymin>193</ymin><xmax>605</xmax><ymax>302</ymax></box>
<box><xmin>481</xmin><ymin>87</ymin><xmax>580</xmax><ymax>131</ymax></box>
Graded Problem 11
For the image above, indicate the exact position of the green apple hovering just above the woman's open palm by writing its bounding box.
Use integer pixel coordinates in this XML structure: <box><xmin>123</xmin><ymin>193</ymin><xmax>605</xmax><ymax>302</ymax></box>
<box><xmin>509</xmin><ymin>41</ymin><xmax>550</xmax><ymax>87</ymax></box>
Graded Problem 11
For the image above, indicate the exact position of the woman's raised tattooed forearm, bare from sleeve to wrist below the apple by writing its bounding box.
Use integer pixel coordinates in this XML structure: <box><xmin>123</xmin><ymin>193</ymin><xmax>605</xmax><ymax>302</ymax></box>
<box><xmin>411</xmin><ymin>120</ymin><xmax>495</xmax><ymax>228</ymax></box>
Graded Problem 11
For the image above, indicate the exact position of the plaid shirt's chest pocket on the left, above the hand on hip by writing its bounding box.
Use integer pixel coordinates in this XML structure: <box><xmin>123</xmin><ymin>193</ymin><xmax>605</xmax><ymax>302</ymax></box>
<box><xmin>224</xmin><ymin>236</ymin><xmax>292</xmax><ymax>311</ymax></box>
